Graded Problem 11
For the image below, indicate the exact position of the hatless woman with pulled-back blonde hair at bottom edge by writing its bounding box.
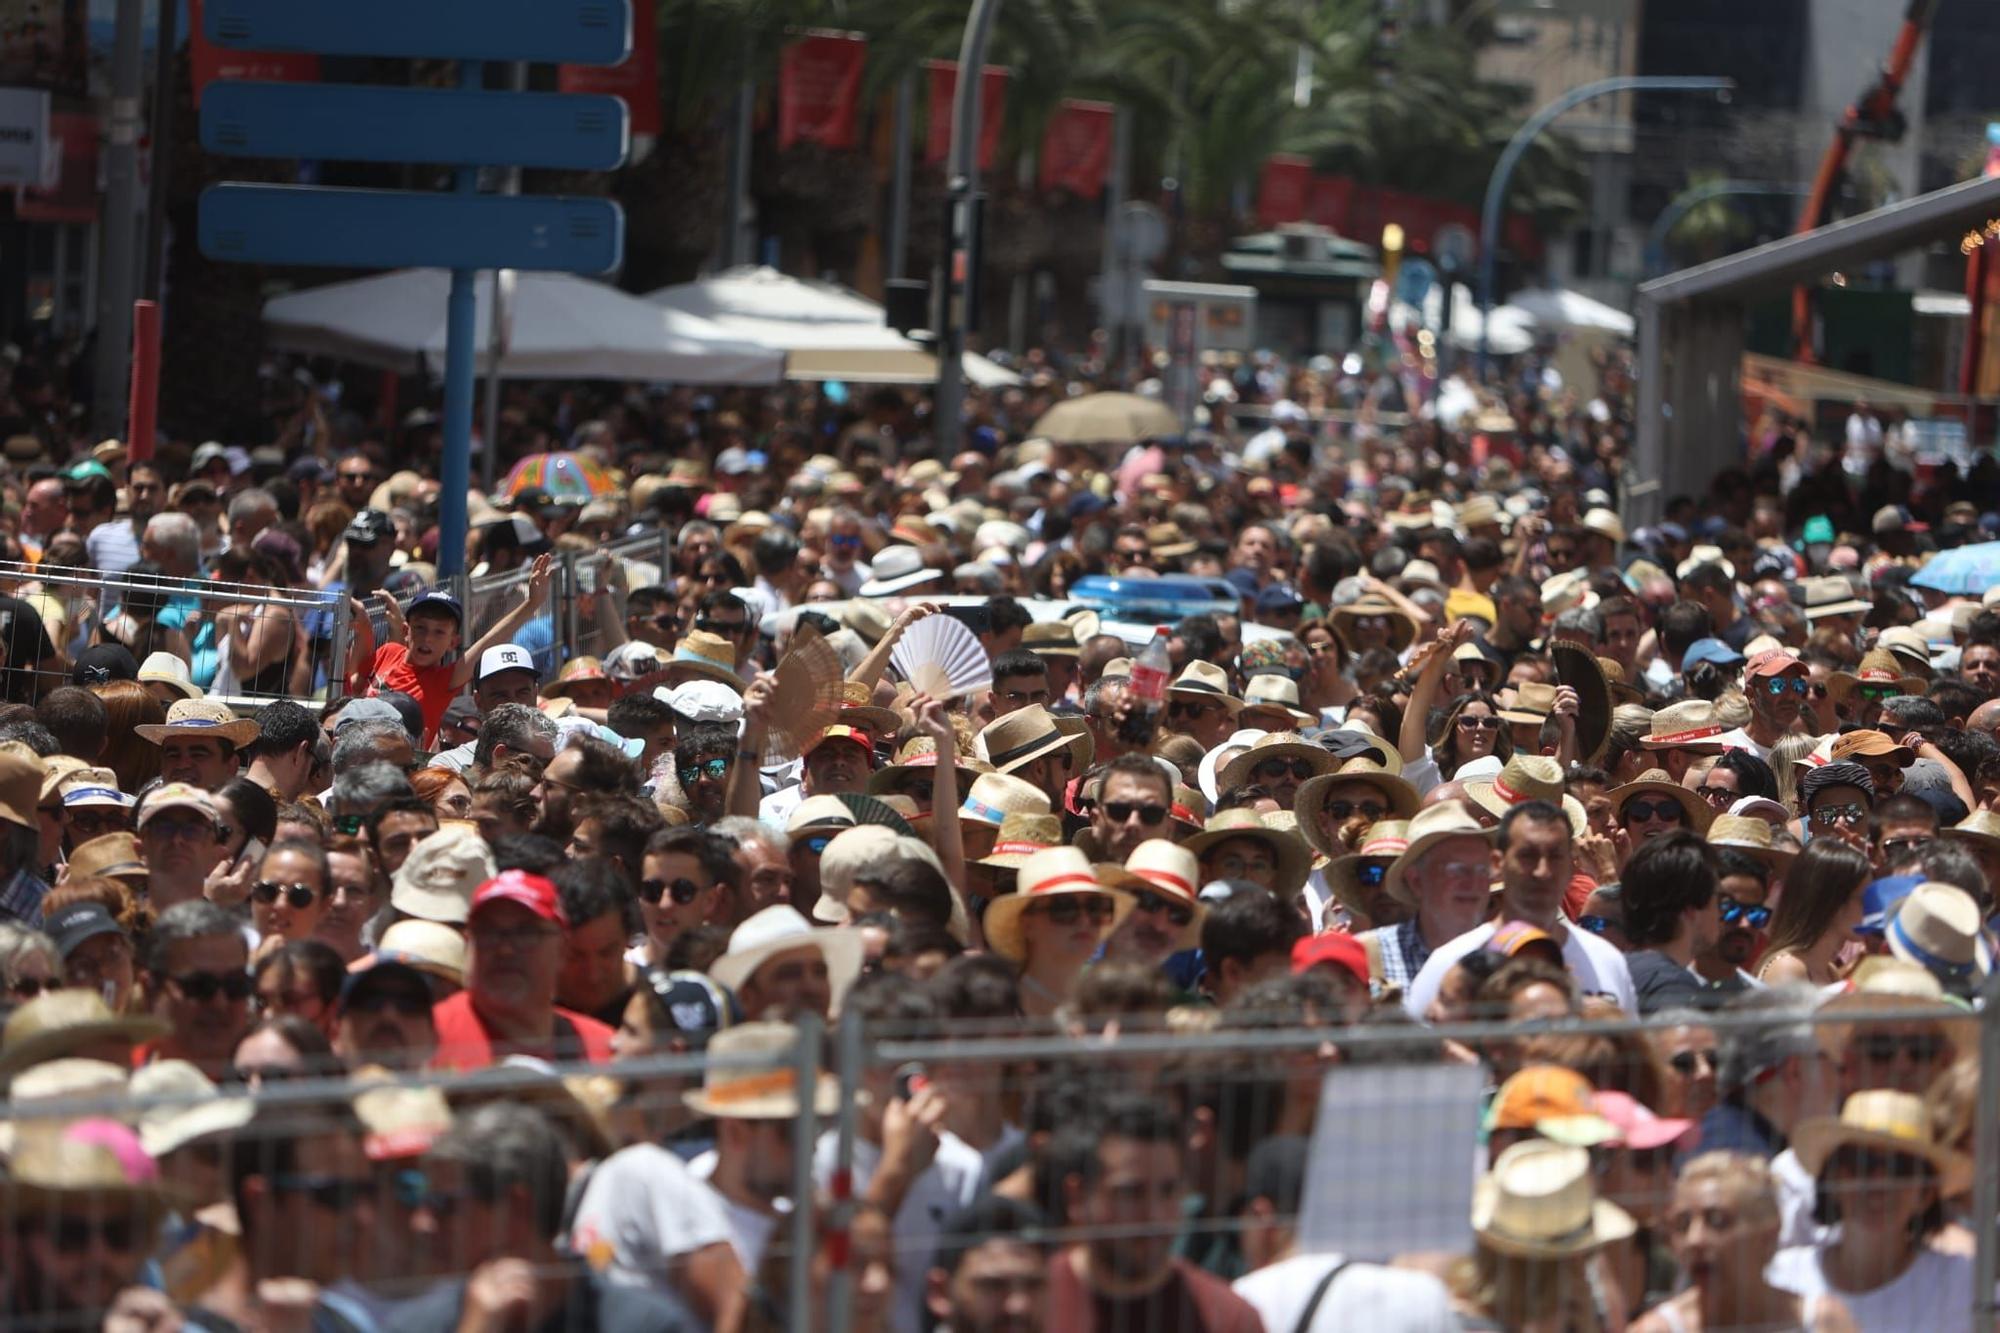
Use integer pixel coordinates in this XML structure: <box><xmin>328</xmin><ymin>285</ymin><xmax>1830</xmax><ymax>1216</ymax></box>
<box><xmin>1632</xmin><ymin>1153</ymin><xmax>1854</xmax><ymax>1333</ymax></box>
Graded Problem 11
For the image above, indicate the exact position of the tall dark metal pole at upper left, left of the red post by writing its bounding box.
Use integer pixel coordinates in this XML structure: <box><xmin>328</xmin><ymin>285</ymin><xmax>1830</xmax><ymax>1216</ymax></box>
<box><xmin>90</xmin><ymin>0</ymin><xmax>146</xmax><ymax>436</ymax></box>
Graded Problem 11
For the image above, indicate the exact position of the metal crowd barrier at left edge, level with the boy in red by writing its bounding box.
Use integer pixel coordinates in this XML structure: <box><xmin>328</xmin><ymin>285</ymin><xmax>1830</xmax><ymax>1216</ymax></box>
<box><xmin>0</xmin><ymin>560</ymin><xmax>350</xmax><ymax>711</ymax></box>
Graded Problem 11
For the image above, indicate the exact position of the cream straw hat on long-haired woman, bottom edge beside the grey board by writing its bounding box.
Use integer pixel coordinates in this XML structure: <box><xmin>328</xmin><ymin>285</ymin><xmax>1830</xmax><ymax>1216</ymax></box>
<box><xmin>1472</xmin><ymin>1139</ymin><xmax>1638</xmax><ymax>1259</ymax></box>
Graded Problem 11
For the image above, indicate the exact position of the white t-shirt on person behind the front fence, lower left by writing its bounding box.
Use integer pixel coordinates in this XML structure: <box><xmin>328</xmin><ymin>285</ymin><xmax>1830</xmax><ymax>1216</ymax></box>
<box><xmin>570</xmin><ymin>1143</ymin><xmax>730</xmax><ymax>1319</ymax></box>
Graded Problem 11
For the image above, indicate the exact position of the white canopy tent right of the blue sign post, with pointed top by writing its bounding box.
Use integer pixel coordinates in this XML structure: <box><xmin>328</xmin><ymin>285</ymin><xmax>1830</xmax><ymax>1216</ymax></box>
<box><xmin>646</xmin><ymin>266</ymin><xmax>1020</xmax><ymax>388</ymax></box>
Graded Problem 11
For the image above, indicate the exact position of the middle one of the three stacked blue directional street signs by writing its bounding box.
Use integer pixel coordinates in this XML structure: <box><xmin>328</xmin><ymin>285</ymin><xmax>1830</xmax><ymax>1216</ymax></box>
<box><xmin>202</xmin><ymin>80</ymin><xmax>630</xmax><ymax>172</ymax></box>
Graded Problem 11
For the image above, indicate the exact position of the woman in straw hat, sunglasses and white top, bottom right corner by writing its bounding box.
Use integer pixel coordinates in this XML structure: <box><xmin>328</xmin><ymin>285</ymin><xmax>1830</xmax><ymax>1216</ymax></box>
<box><xmin>1770</xmin><ymin>1089</ymin><xmax>1974</xmax><ymax>1333</ymax></box>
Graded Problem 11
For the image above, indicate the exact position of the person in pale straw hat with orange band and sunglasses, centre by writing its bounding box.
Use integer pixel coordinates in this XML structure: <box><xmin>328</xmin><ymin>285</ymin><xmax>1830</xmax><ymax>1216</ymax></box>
<box><xmin>984</xmin><ymin>847</ymin><xmax>1132</xmax><ymax>1019</ymax></box>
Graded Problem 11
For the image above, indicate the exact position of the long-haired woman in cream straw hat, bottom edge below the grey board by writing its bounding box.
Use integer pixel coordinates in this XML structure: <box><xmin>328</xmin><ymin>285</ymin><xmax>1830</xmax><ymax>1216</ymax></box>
<box><xmin>1458</xmin><ymin>1139</ymin><xmax>1634</xmax><ymax>1331</ymax></box>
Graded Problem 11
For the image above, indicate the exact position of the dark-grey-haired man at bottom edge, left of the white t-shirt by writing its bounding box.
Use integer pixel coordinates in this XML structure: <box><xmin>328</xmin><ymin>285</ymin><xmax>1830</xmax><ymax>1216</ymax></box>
<box><xmin>386</xmin><ymin>1103</ymin><xmax>698</xmax><ymax>1333</ymax></box>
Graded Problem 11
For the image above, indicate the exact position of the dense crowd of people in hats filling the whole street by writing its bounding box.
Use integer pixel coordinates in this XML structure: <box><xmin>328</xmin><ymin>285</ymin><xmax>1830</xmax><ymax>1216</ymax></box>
<box><xmin>0</xmin><ymin>344</ymin><xmax>2000</xmax><ymax>1333</ymax></box>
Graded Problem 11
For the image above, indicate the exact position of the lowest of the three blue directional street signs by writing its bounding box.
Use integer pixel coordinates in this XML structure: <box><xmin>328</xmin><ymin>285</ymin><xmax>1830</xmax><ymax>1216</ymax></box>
<box><xmin>202</xmin><ymin>184</ymin><xmax>624</xmax><ymax>272</ymax></box>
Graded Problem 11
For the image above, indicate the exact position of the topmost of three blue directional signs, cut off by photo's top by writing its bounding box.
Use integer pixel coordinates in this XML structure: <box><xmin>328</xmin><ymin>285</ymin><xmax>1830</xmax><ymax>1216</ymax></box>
<box><xmin>202</xmin><ymin>0</ymin><xmax>632</xmax><ymax>66</ymax></box>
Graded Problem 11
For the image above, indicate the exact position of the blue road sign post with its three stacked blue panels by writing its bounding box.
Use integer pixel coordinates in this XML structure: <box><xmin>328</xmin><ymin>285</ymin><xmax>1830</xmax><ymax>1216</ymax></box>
<box><xmin>200</xmin><ymin>0</ymin><xmax>632</xmax><ymax>582</ymax></box>
